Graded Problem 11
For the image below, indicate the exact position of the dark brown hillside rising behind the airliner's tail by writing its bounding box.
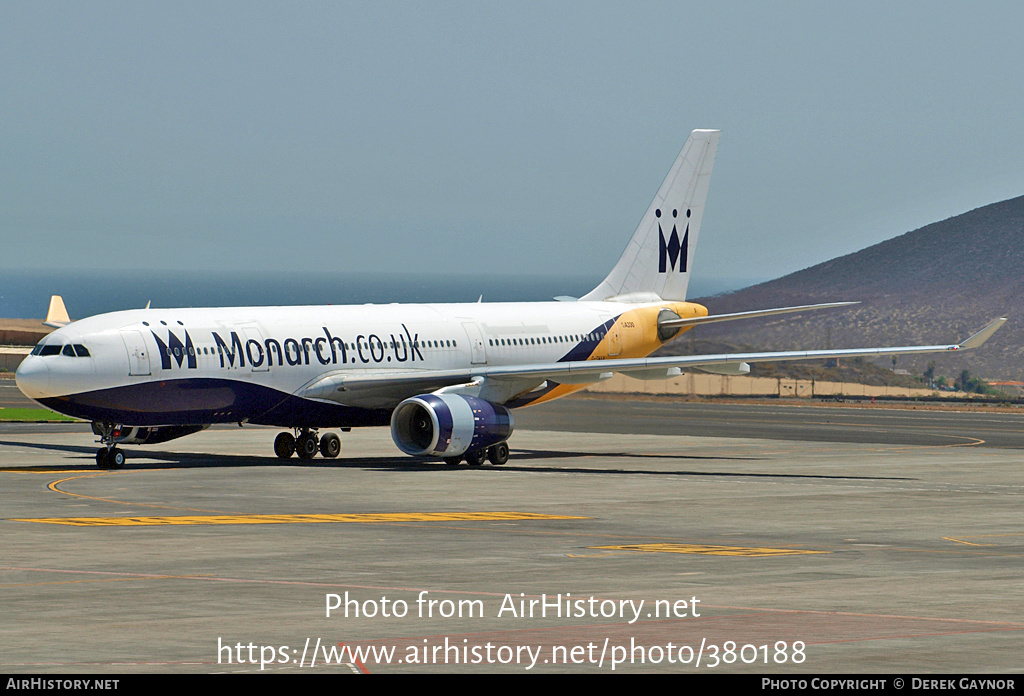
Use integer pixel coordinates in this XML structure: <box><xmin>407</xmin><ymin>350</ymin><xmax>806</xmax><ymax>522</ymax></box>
<box><xmin>663</xmin><ymin>197</ymin><xmax>1024</xmax><ymax>380</ymax></box>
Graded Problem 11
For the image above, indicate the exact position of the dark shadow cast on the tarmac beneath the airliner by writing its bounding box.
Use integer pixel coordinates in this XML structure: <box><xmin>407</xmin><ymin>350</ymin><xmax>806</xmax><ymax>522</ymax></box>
<box><xmin>0</xmin><ymin>440</ymin><xmax>913</xmax><ymax>481</ymax></box>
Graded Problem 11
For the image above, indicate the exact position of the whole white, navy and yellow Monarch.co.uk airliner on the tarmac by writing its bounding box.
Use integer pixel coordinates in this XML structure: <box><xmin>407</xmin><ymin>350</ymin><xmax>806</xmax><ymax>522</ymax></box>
<box><xmin>15</xmin><ymin>130</ymin><xmax>1006</xmax><ymax>469</ymax></box>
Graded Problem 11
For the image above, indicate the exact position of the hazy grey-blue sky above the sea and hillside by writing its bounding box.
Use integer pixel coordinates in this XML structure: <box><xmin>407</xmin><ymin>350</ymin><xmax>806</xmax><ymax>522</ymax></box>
<box><xmin>0</xmin><ymin>0</ymin><xmax>1024</xmax><ymax>290</ymax></box>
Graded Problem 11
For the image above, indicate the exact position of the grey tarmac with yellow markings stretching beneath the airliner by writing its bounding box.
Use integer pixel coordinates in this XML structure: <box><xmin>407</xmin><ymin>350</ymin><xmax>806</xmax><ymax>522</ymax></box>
<box><xmin>0</xmin><ymin>399</ymin><xmax>1024</xmax><ymax>673</ymax></box>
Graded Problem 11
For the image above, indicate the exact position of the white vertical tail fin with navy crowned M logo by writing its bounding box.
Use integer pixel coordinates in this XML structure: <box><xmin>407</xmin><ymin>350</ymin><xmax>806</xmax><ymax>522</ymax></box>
<box><xmin>580</xmin><ymin>130</ymin><xmax>721</xmax><ymax>301</ymax></box>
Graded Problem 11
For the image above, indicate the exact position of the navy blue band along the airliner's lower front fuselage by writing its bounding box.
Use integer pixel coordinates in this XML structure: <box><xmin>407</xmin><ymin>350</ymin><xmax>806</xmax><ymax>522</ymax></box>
<box><xmin>37</xmin><ymin>379</ymin><xmax>391</xmax><ymax>428</ymax></box>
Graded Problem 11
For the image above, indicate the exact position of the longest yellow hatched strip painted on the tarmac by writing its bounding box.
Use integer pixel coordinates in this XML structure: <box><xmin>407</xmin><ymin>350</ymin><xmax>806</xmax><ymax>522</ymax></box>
<box><xmin>11</xmin><ymin>512</ymin><xmax>588</xmax><ymax>527</ymax></box>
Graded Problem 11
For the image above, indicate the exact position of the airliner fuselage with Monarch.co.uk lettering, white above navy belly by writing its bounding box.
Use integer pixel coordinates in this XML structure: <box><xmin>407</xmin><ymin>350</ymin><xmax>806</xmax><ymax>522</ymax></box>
<box><xmin>17</xmin><ymin>302</ymin><xmax>672</xmax><ymax>427</ymax></box>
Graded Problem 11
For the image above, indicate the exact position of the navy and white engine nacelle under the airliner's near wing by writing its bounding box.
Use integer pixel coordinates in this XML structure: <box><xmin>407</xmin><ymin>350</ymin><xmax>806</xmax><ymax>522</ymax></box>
<box><xmin>391</xmin><ymin>394</ymin><xmax>512</xmax><ymax>456</ymax></box>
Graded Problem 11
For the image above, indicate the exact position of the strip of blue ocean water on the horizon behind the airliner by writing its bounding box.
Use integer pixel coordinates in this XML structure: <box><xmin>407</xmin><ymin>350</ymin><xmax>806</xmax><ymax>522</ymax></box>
<box><xmin>0</xmin><ymin>268</ymin><xmax>753</xmax><ymax>319</ymax></box>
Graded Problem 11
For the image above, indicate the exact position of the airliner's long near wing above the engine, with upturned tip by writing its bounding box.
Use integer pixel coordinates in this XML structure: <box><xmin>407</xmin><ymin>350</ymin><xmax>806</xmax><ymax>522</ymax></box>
<box><xmin>297</xmin><ymin>317</ymin><xmax>1007</xmax><ymax>407</ymax></box>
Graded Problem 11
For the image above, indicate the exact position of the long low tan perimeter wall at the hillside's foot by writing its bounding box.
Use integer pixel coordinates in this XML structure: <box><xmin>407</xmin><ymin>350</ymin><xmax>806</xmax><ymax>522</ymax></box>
<box><xmin>587</xmin><ymin>373</ymin><xmax>950</xmax><ymax>398</ymax></box>
